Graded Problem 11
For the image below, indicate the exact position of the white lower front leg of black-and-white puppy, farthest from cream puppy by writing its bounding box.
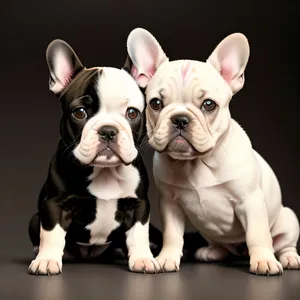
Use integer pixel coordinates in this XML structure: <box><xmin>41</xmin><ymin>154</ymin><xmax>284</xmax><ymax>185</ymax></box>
<box><xmin>29</xmin><ymin>224</ymin><xmax>66</xmax><ymax>274</ymax></box>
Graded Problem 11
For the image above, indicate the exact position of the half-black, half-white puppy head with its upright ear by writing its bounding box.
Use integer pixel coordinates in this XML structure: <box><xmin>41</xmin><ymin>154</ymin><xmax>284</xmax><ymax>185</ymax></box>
<box><xmin>46</xmin><ymin>40</ymin><xmax>145</xmax><ymax>167</ymax></box>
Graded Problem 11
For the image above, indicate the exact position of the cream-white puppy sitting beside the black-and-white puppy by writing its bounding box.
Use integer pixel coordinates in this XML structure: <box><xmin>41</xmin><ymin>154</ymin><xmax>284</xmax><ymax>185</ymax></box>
<box><xmin>127</xmin><ymin>28</ymin><xmax>300</xmax><ymax>275</ymax></box>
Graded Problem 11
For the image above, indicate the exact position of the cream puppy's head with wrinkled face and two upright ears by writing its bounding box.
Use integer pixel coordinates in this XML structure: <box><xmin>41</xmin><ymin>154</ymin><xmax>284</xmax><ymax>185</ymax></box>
<box><xmin>127</xmin><ymin>28</ymin><xmax>250</xmax><ymax>160</ymax></box>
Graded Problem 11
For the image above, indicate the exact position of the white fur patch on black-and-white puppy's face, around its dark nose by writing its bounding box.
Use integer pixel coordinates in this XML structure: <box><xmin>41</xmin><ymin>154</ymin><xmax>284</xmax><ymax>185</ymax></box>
<box><xmin>74</xmin><ymin>67</ymin><xmax>145</xmax><ymax>167</ymax></box>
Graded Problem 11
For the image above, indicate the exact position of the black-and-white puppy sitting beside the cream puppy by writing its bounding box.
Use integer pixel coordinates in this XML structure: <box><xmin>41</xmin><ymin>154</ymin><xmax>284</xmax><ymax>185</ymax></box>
<box><xmin>29</xmin><ymin>40</ymin><xmax>159</xmax><ymax>275</ymax></box>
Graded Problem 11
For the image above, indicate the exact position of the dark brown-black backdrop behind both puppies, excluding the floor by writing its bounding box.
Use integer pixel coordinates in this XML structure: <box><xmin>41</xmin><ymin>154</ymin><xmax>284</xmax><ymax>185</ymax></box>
<box><xmin>0</xmin><ymin>0</ymin><xmax>300</xmax><ymax>258</ymax></box>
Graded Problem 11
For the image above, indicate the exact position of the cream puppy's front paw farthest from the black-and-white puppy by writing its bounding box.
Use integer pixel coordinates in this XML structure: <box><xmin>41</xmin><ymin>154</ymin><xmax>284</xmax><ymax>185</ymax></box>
<box><xmin>249</xmin><ymin>249</ymin><xmax>283</xmax><ymax>276</ymax></box>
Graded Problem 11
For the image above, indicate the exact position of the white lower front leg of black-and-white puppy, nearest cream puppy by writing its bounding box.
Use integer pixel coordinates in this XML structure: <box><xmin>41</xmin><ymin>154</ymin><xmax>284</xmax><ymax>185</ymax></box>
<box><xmin>126</xmin><ymin>220</ymin><xmax>160</xmax><ymax>273</ymax></box>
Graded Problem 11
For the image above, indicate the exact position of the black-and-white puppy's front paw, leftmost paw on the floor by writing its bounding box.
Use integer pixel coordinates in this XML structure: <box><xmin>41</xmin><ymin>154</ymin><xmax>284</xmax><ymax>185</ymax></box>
<box><xmin>28</xmin><ymin>259</ymin><xmax>62</xmax><ymax>275</ymax></box>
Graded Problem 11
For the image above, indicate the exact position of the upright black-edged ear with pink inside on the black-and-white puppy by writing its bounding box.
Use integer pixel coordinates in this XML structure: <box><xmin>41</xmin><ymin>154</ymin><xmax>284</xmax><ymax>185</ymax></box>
<box><xmin>46</xmin><ymin>40</ymin><xmax>83</xmax><ymax>94</ymax></box>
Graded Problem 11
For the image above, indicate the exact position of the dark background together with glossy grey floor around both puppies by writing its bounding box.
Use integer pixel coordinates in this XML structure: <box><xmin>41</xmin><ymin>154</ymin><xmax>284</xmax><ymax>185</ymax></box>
<box><xmin>0</xmin><ymin>0</ymin><xmax>300</xmax><ymax>300</ymax></box>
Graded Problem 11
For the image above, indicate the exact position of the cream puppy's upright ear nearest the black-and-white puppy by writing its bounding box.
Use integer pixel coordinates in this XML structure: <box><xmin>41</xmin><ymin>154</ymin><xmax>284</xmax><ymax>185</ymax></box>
<box><xmin>125</xmin><ymin>28</ymin><xmax>169</xmax><ymax>88</ymax></box>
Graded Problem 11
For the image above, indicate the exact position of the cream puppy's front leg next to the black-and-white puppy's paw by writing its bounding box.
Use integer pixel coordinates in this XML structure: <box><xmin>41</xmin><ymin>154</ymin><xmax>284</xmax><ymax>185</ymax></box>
<box><xmin>156</xmin><ymin>195</ymin><xmax>185</xmax><ymax>272</ymax></box>
